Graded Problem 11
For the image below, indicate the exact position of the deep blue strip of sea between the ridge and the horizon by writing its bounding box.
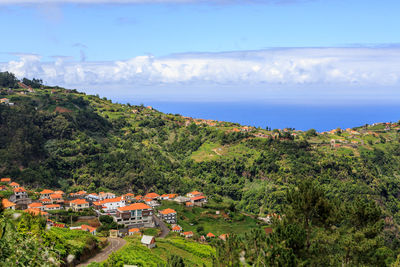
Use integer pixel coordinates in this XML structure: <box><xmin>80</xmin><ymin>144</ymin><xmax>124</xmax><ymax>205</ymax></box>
<box><xmin>114</xmin><ymin>100</ymin><xmax>400</xmax><ymax>131</ymax></box>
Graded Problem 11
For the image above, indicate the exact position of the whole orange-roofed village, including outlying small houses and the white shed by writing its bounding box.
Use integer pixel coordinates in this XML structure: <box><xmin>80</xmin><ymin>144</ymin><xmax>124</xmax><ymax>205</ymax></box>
<box><xmin>0</xmin><ymin>178</ymin><xmax>239</xmax><ymax>248</ymax></box>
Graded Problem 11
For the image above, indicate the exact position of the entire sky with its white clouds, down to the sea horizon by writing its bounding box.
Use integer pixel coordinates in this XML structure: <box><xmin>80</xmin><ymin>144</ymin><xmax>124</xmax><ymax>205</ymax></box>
<box><xmin>0</xmin><ymin>0</ymin><xmax>400</xmax><ymax>129</ymax></box>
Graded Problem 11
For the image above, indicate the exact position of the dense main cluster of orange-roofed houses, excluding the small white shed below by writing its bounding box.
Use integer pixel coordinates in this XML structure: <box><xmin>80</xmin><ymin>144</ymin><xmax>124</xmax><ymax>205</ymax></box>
<box><xmin>0</xmin><ymin>178</ymin><xmax>211</xmax><ymax>243</ymax></box>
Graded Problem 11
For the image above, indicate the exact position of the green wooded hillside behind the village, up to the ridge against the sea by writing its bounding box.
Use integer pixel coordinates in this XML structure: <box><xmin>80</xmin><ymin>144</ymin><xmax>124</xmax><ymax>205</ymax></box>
<box><xmin>0</xmin><ymin>81</ymin><xmax>400</xmax><ymax>221</ymax></box>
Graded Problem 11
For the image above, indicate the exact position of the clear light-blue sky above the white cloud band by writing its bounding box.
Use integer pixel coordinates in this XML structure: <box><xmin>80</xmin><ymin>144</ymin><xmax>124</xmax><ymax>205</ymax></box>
<box><xmin>0</xmin><ymin>0</ymin><xmax>400</xmax><ymax>61</ymax></box>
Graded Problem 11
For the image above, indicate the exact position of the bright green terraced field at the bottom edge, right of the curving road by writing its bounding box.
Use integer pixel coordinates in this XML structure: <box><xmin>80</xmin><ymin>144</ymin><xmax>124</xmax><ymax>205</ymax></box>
<box><xmin>89</xmin><ymin>237</ymin><xmax>215</xmax><ymax>267</ymax></box>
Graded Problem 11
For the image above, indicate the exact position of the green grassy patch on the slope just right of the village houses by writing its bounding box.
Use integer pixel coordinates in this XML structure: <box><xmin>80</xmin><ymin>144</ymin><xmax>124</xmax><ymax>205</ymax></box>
<box><xmin>159</xmin><ymin>201</ymin><xmax>260</xmax><ymax>235</ymax></box>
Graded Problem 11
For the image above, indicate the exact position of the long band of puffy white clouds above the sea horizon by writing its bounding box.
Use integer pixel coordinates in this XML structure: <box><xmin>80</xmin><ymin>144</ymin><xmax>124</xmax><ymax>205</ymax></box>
<box><xmin>0</xmin><ymin>48</ymin><xmax>400</xmax><ymax>89</ymax></box>
